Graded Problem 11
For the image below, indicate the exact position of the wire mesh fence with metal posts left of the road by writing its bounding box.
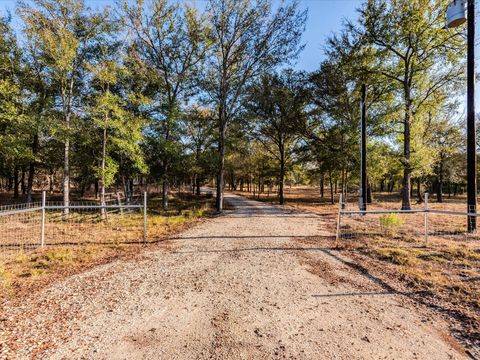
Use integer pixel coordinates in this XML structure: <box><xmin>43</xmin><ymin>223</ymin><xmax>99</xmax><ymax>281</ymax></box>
<box><xmin>0</xmin><ymin>194</ymin><xmax>147</xmax><ymax>259</ymax></box>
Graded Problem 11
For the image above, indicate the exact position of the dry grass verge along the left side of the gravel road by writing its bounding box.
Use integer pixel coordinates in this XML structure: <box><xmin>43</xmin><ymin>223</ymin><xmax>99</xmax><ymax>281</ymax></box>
<box><xmin>0</xmin><ymin>193</ymin><xmax>213</xmax><ymax>300</ymax></box>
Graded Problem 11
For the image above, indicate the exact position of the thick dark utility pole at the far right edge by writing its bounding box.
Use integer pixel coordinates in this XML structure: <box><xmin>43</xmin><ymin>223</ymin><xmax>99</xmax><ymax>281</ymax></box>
<box><xmin>467</xmin><ymin>0</ymin><xmax>477</xmax><ymax>232</ymax></box>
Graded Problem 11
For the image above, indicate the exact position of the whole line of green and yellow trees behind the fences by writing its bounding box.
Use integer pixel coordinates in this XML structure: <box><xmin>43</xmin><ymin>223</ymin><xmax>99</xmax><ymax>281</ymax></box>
<box><xmin>0</xmin><ymin>0</ymin><xmax>466</xmax><ymax>211</ymax></box>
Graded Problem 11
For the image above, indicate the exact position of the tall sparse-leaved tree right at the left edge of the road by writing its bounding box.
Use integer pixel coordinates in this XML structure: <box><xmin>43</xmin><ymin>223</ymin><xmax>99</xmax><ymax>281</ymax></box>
<box><xmin>204</xmin><ymin>0</ymin><xmax>306</xmax><ymax>211</ymax></box>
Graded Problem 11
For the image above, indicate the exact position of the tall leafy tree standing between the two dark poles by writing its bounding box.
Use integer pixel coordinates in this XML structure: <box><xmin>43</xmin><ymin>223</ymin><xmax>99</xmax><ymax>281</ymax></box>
<box><xmin>348</xmin><ymin>0</ymin><xmax>465</xmax><ymax>209</ymax></box>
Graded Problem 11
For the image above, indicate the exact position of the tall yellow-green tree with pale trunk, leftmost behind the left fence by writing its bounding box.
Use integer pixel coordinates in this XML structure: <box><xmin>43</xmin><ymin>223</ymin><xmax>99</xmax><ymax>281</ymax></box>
<box><xmin>18</xmin><ymin>0</ymin><xmax>108</xmax><ymax>212</ymax></box>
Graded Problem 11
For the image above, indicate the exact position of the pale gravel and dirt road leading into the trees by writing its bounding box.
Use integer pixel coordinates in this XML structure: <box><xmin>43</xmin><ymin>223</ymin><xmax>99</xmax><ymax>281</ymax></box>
<box><xmin>0</xmin><ymin>195</ymin><xmax>464</xmax><ymax>360</ymax></box>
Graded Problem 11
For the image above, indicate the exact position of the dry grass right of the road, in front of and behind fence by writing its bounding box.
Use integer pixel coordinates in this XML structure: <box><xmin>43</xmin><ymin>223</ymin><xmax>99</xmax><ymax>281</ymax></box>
<box><xmin>244</xmin><ymin>187</ymin><xmax>480</xmax><ymax>346</ymax></box>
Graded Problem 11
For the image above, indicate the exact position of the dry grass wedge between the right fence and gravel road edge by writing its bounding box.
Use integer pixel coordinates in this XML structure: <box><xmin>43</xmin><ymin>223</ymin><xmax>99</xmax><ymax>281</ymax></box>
<box><xmin>334</xmin><ymin>237</ymin><xmax>480</xmax><ymax>348</ymax></box>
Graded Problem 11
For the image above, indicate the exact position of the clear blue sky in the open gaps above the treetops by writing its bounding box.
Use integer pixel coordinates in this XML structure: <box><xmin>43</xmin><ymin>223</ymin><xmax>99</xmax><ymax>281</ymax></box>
<box><xmin>0</xmin><ymin>0</ymin><xmax>362</xmax><ymax>70</ymax></box>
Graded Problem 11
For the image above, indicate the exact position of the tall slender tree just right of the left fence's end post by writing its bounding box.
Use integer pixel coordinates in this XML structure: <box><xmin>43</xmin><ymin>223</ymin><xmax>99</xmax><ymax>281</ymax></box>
<box><xmin>123</xmin><ymin>0</ymin><xmax>211</xmax><ymax>209</ymax></box>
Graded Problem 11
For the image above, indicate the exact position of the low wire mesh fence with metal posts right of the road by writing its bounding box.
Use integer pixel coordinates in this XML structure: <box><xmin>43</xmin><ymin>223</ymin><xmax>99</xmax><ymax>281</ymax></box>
<box><xmin>337</xmin><ymin>194</ymin><xmax>480</xmax><ymax>245</ymax></box>
